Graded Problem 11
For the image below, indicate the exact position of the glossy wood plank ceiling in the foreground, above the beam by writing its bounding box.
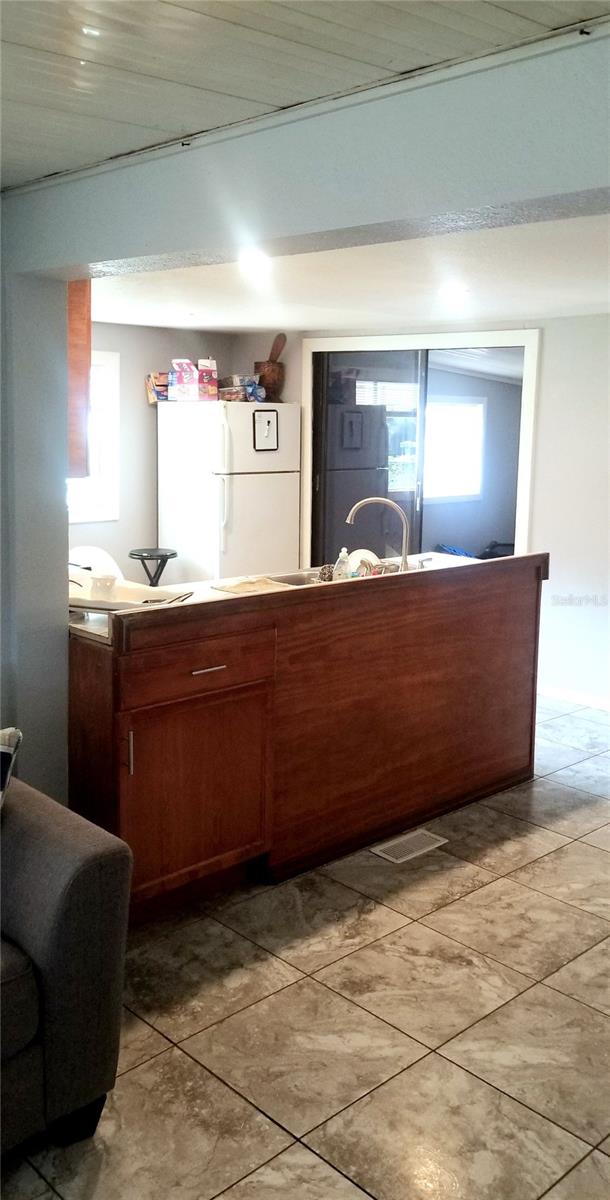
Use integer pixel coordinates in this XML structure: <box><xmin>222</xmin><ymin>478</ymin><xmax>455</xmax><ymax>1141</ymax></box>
<box><xmin>1</xmin><ymin>0</ymin><xmax>610</xmax><ymax>187</ymax></box>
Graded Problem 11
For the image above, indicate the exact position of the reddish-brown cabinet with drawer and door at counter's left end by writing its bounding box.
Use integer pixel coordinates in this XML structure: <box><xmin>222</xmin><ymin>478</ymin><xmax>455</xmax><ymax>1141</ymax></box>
<box><xmin>70</xmin><ymin>628</ymin><xmax>275</xmax><ymax>900</ymax></box>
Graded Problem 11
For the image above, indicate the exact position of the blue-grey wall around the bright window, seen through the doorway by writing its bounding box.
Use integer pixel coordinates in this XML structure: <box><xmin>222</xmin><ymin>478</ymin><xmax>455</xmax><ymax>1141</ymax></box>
<box><xmin>421</xmin><ymin>366</ymin><xmax>521</xmax><ymax>554</ymax></box>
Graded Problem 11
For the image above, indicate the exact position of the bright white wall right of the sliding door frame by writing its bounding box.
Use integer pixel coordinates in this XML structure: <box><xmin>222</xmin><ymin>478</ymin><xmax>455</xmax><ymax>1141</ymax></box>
<box><xmin>532</xmin><ymin>316</ymin><xmax>610</xmax><ymax>706</ymax></box>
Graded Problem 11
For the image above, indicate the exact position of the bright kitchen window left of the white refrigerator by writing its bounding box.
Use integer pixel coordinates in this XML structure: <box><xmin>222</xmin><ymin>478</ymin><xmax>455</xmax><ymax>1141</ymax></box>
<box><xmin>66</xmin><ymin>350</ymin><xmax>120</xmax><ymax>524</ymax></box>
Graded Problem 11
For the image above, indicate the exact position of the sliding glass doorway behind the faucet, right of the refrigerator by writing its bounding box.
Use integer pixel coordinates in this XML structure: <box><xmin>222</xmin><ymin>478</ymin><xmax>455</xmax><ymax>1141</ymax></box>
<box><xmin>304</xmin><ymin>335</ymin><xmax>536</xmax><ymax>566</ymax></box>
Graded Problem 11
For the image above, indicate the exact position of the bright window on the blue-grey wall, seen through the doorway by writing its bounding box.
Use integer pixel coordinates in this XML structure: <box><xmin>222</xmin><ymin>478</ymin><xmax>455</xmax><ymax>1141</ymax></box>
<box><xmin>424</xmin><ymin>396</ymin><xmax>485</xmax><ymax>500</ymax></box>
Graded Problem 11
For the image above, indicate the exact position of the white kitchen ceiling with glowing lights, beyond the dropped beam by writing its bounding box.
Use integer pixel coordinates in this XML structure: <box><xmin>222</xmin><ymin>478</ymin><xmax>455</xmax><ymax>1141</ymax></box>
<box><xmin>92</xmin><ymin>216</ymin><xmax>610</xmax><ymax>332</ymax></box>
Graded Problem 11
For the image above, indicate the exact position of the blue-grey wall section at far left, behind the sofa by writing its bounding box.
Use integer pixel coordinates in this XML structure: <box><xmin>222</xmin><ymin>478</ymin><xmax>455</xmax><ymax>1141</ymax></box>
<box><xmin>0</xmin><ymin>276</ymin><xmax>67</xmax><ymax>799</ymax></box>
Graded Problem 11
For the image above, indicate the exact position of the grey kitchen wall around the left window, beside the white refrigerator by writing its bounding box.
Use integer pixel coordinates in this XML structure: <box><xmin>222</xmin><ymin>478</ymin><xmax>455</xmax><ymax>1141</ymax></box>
<box><xmin>70</xmin><ymin>323</ymin><xmax>232</xmax><ymax>580</ymax></box>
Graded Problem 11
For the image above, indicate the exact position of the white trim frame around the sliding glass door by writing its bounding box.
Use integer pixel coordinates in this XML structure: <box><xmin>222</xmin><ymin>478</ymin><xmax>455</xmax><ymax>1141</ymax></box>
<box><xmin>300</xmin><ymin>329</ymin><xmax>540</xmax><ymax>568</ymax></box>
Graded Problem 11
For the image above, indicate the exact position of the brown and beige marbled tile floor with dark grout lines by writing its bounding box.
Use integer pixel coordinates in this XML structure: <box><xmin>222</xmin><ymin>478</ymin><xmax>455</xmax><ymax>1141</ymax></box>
<box><xmin>2</xmin><ymin>700</ymin><xmax>610</xmax><ymax>1200</ymax></box>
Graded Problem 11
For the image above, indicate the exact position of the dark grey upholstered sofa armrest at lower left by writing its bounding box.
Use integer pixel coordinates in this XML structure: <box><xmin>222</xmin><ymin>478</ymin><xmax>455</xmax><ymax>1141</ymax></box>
<box><xmin>1</xmin><ymin>780</ymin><xmax>132</xmax><ymax>1122</ymax></box>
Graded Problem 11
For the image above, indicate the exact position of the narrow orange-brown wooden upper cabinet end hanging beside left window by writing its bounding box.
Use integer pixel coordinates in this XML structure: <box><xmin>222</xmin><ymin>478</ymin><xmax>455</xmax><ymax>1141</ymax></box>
<box><xmin>67</xmin><ymin>280</ymin><xmax>91</xmax><ymax>479</ymax></box>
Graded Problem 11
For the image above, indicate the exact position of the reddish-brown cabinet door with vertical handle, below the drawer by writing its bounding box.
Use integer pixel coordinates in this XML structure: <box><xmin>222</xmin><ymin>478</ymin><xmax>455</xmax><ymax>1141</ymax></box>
<box><xmin>119</xmin><ymin>684</ymin><xmax>271</xmax><ymax>895</ymax></box>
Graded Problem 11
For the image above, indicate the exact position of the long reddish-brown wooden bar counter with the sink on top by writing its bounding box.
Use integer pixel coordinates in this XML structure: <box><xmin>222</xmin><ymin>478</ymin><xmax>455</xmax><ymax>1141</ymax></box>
<box><xmin>70</xmin><ymin>554</ymin><xmax>549</xmax><ymax>899</ymax></box>
